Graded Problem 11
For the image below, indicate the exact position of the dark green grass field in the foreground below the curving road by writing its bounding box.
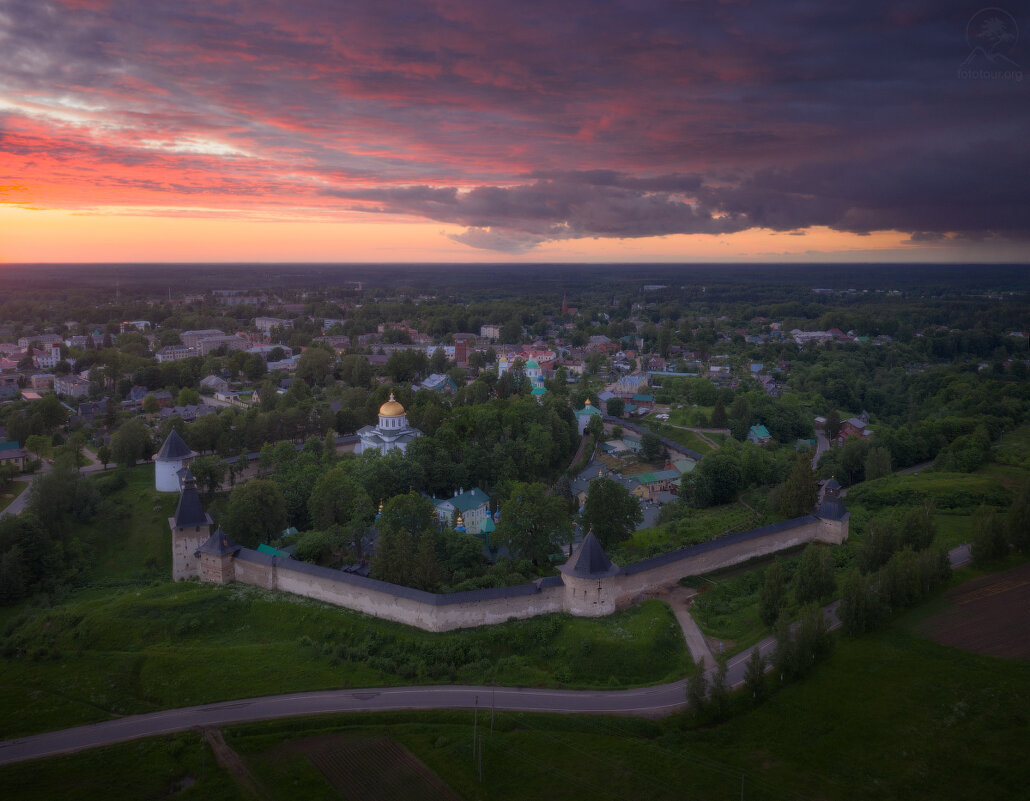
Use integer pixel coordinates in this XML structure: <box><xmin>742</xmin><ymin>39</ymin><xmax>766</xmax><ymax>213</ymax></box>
<box><xmin>0</xmin><ymin>601</ymin><xmax>1030</xmax><ymax>801</ymax></box>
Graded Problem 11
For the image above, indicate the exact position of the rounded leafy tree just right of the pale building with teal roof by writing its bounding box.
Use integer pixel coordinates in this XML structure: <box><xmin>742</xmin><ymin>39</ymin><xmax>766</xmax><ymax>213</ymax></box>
<box><xmin>495</xmin><ymin>482</ymin><xmax>572</xmax><ymax>564</ymax></box>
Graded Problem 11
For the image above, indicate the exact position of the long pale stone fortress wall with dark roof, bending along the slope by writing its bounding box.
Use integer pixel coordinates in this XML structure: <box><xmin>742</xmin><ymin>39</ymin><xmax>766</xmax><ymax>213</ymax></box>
<box><xmin>194</xmin><ymin>515</ymin><xmax>848</xmax><ymax>631</ymax></box>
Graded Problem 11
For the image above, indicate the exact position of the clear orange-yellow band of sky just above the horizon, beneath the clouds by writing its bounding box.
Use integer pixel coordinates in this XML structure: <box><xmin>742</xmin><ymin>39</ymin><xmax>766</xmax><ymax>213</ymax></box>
<box><xmin>0</xmin><ymin>206</ymin><xmax>992</xmax><ymax>264</ymax></box>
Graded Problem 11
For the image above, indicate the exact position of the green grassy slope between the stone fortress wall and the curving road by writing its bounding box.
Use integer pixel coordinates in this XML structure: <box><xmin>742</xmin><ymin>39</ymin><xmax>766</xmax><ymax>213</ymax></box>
<box><xmin>0</xmin><ymin>582</ymin><xmax>686</xmax><ymax>737</ymax></box>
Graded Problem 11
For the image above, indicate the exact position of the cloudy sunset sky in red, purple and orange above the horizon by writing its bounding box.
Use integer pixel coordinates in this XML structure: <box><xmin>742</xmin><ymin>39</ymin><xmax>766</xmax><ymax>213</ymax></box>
<box><xmin>0</xmin><ymin>0</ymin><xmax>1030</xmax><ymax>262</ymax></box>
